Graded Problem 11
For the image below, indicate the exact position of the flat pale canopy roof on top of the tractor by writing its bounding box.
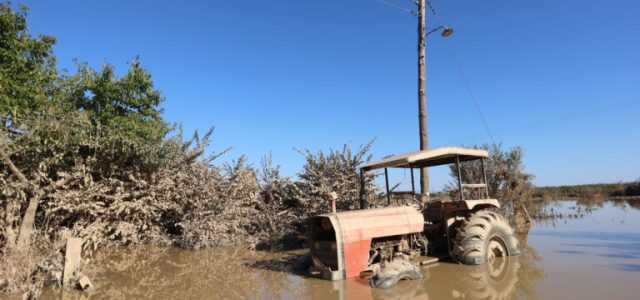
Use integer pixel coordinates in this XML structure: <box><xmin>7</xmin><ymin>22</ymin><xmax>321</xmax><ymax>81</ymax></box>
<box><xmin>362</xmin><ymin>147</ymin><xmax>489</xmax><ymax>171</ymax></box>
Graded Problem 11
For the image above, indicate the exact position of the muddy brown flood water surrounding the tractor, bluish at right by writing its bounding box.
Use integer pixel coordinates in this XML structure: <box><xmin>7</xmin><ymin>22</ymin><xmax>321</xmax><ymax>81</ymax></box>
<box><xmin>36</xmin><ymin>200</ymin><xmax>640</xmax><ymax>299</ymax></box>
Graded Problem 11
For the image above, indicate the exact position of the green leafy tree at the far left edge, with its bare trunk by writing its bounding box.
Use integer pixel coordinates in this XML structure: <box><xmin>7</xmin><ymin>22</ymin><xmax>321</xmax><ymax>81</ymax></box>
<box><xmin>0</xmin><ymin>3</ymin><xmax>58</xmax><ymax>250</ymax></box>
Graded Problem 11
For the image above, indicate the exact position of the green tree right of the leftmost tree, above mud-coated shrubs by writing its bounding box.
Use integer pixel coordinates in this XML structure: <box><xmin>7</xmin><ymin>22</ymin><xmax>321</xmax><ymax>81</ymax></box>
<box><xmin>65</xmin><ymin>58</ymin><xmax>172</xmax><ymax>177</ymax></box>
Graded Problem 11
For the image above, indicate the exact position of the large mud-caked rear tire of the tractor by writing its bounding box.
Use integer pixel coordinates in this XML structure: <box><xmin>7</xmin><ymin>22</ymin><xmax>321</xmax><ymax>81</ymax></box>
<box><xmin>451</xmin><ymin>210</ymin><xmax>520</xmax><ymax>265</ymax></box>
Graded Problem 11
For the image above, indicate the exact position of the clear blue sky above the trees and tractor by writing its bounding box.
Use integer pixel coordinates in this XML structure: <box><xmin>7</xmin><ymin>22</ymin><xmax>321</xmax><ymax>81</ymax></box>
<box><xmin>15</xmin><ymin>0</ymin><xmax>640</xmax><ymax>189</ymax></box>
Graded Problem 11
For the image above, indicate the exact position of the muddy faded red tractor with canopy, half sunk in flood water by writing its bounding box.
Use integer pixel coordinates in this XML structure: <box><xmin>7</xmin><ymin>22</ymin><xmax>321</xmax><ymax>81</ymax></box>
<box><xmin>308</xmin><ymin>147</ymin><xmax>519</xmax><ymax>288</ymax></box>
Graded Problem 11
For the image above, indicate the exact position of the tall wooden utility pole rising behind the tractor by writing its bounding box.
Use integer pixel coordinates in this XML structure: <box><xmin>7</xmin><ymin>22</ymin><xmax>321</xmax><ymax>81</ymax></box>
<box><xmin>414</xmin><ymin>0</ymin><xmax>429</xmax><ymax>201</ymax></box>
